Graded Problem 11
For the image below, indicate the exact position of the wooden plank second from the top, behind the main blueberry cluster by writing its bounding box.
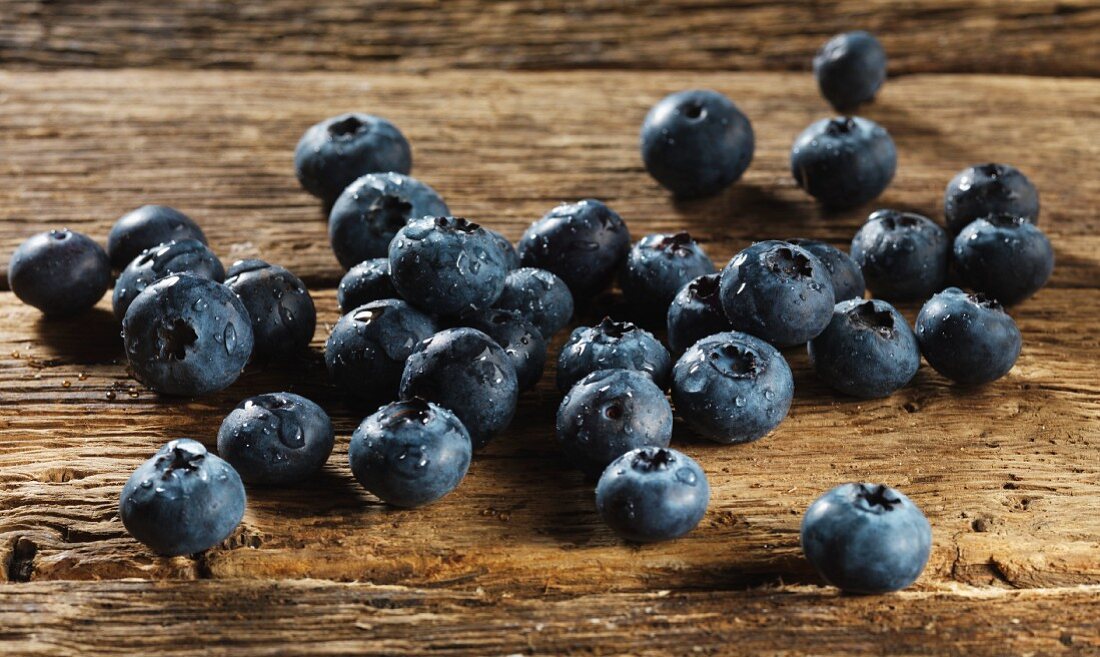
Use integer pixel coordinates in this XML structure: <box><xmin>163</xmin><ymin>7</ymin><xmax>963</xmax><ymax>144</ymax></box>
<box><xmin>0</xmin><ymin>72</ymin><xmax>1100</xmax><ymax>287</ymax></box>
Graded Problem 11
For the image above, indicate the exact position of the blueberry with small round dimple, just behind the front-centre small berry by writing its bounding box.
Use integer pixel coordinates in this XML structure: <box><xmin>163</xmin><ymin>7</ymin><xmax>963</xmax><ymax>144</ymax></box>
<box><xmin>558</xmin><ymin>370</ymin><xmax>672</xmax><ymax>475</ymax></box>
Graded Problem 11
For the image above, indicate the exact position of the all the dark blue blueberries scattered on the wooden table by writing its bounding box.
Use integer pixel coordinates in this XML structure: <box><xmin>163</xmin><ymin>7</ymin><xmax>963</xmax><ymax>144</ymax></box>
<box><xmin>9</xmin><ymin>32</ymin><xmax>1053</xmax><ymax>592</ymax></box>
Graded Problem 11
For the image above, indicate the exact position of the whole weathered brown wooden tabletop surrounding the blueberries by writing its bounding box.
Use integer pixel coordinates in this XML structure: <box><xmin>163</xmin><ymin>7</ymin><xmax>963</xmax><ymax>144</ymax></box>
<box><xmin>0</xmin><ymin>0</ymin><xmax>1100</xmax><ymax>657</ymax></box>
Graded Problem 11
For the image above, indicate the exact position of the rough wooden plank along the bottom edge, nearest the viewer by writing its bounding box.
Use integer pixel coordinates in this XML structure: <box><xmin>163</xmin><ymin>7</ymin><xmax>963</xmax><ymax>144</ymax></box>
<box><xmin>0</xmin><ymin>581</ymin><xmax>1100</xmax><ymax>657</ymax></box>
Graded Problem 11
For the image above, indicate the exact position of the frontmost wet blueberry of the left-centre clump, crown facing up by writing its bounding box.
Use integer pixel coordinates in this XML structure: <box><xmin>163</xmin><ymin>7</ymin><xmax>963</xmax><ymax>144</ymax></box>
<box><xmin>348</xmin><ymin>398</ymin><xmax>473</xmax><ymax>507</ymax></box>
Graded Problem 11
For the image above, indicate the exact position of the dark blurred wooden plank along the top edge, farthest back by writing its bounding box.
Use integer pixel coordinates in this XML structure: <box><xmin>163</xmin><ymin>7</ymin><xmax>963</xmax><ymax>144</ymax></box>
<box><xmin>0</xmin><ymin>0</ymin><xmax>1100</xmax><ymax>75</ymax></box>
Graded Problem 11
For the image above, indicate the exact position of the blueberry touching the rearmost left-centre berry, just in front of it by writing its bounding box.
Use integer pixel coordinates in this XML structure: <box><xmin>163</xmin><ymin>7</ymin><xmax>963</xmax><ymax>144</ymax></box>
<box><xmin>329</xmin><ymin>173</ymin><xmax>451</xmax><ymax>270</ymax></box>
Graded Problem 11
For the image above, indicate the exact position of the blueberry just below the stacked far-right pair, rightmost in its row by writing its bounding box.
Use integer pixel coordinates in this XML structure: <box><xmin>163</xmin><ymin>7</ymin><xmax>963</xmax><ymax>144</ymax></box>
<box><xmin>916</xmin><ymin>287</ymin><xmax>1021</xmax><ymax>384</ymax></box>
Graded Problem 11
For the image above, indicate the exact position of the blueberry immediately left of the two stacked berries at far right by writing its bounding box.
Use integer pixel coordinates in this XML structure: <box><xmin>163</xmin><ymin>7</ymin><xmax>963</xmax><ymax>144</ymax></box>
<box><xmin>851</xmin><ymin>210</ymin><xmax>950</xmax><ymax>300</ymax></box>
